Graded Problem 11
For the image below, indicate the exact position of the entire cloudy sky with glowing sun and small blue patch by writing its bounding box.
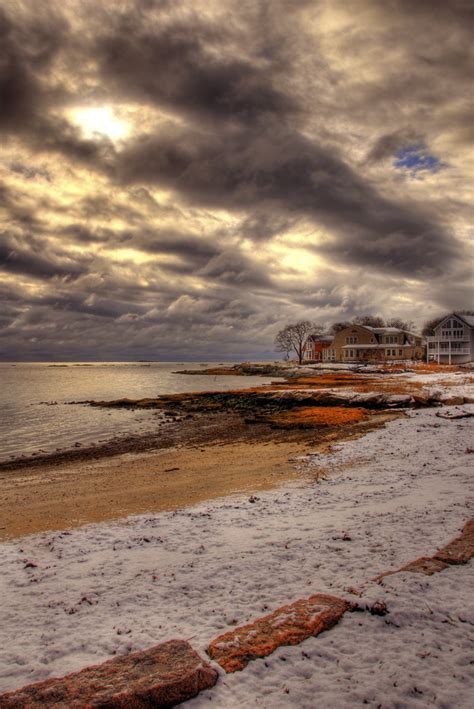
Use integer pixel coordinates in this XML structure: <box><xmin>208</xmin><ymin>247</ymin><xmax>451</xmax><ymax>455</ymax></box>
<box><xmin>0</xmin><ymin>0</ymin><xmax>474</xmax><ymax>361</ymax></box>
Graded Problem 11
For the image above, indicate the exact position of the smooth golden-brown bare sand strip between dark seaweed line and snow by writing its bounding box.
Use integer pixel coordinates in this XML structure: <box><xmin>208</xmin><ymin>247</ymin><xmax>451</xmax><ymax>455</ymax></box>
<box><xmin>0</xmin><ymin>441</ymin><xmax>310</xmax><ymax>539</ymax></box>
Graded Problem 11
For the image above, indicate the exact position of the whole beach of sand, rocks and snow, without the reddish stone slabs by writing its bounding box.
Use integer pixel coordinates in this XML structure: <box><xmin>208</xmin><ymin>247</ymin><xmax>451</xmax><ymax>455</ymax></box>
<box><xmin>0</xmin><ymin>368</ymin><xmax>474</xmax><ymax>709</ymax></box>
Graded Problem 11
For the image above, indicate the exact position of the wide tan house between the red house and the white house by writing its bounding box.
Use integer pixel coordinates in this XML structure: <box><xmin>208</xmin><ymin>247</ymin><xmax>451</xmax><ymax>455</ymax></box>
<box><xmin>322</xmin><ymin>325</ymin><xmax>424</xmax><ymax>362</ymax></box>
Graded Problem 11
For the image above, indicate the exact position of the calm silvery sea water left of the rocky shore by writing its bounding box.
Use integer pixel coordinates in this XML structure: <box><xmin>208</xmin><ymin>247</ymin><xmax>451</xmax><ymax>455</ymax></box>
<box><xmin>0</xmin><ymin>362</ymin><xmax>278</xmax><ymax>462</ymax></box>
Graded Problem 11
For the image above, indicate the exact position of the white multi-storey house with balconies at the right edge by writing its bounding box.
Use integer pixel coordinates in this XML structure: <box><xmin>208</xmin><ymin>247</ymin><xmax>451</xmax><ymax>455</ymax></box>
<box><xmin>427</xmin><ymin>313</ymin><xmax>474</xmax><ymax>364</ymax></box>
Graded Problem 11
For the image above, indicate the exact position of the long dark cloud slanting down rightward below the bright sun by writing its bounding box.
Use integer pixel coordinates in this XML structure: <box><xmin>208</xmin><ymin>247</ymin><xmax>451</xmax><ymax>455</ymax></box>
<box><xmin>118</xmin><ymin>124</ymin><xmax>458</xmax><ymax>273</ymax></box>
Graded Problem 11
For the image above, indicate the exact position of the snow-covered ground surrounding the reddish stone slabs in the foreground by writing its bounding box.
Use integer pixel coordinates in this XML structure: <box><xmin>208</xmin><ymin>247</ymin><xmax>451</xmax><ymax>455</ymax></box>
<box><xmin>0</xmin><ymin>405</ymin><xmax>474</xmax><ymax>709</ymax></box>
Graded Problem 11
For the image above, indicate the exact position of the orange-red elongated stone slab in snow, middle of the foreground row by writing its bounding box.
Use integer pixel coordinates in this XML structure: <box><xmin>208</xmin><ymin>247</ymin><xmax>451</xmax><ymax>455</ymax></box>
<box><xmin>207</xmin><ymin>593</ymin><xmax>349</xmax><ymax>672</ymax></box>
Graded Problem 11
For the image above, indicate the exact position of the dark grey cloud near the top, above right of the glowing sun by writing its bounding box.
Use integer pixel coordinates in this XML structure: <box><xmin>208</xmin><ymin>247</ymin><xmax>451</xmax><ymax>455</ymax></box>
<box><xmin>96</xmin><ymin>2</ymin><xmax>297</xmax><ymax>123</ymax></box>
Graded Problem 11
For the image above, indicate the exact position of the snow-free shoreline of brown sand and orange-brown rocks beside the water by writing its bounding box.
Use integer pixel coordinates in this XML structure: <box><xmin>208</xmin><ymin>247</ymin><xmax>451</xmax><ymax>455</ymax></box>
<box><xmin>0</xmin><ymin>366</ymin><xmax>473</xmax><ymax>539</ymax></box>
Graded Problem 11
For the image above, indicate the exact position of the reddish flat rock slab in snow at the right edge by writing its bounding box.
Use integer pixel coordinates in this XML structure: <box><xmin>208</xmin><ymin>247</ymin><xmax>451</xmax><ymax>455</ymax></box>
<box><xmin>374</xmin><ymin>518</ymin><xmax>474</xmax><ymax>581</ymax></box>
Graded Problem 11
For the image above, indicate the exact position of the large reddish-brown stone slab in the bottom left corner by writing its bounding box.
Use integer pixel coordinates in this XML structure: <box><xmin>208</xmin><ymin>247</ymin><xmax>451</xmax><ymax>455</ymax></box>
<box><xmin>0</xmin><ymin>640</ymin><xmax>217</xmax><ymax>709</ymax></box>
